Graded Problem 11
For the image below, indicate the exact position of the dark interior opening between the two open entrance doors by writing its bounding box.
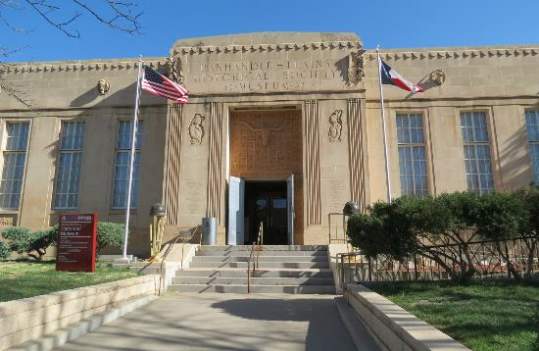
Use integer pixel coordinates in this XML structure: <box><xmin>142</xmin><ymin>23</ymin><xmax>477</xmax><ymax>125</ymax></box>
<box><xmin>245</xmin><ymin>181</ymin><xmax>288</xmax><ymax>245</ymax></box>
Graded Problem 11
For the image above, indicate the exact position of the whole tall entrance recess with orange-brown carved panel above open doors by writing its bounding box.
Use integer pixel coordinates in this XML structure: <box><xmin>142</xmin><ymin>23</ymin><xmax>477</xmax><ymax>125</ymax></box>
<box><xmin>227</xmin><ymin>106</ymin><xmax>303</xmax><ymax>245</ymax></box>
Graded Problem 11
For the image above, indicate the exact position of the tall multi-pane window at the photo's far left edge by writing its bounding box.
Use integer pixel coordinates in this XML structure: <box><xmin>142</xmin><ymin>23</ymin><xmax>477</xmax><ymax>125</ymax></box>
<box><xmin>0</xmin><ymin>122</ymin><xmax>29</xmax><ymax>210</ymax></box>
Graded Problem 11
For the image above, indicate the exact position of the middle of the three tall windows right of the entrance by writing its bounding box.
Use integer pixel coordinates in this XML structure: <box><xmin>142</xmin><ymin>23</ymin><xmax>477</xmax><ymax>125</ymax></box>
<box><xmin>460</xmin><ymin>112</ymin><xmax>494</xmax><ymax>194</ymax></box>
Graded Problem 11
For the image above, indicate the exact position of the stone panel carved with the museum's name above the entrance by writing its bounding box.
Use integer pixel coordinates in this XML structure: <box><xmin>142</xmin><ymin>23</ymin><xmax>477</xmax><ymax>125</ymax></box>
<box><xmin>176</xmin><ymin>43</ymin><xmax>361</xmax><ymax>95</ymax></box>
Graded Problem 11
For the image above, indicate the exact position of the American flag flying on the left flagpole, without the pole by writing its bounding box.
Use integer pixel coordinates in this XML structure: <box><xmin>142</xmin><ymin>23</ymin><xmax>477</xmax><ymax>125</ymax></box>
<box><xmin>142</xmin><ymin>67</ymin><xmax>189</xmax><ymax>104</ymax></box>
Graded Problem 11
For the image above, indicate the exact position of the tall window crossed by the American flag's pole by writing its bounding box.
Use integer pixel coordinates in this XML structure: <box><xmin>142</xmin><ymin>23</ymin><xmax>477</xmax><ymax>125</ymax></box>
<box><xmin>112</xmin><ymin>121</ymin><xmax>143</xmax><ymax>209</ymax></box>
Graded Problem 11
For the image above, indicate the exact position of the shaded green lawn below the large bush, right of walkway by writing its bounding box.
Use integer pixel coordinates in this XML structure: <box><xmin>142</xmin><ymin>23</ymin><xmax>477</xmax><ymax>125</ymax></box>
<box><xmin>369</xmin><ymin>281</ymin><xmax>539</xmax><ymax>351</ymax></box>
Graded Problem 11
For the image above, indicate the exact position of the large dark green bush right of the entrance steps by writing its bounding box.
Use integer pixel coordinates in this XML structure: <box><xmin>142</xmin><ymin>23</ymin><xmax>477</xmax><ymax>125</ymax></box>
<box><xmin>347</xmin><ymin>189</ymin><xmax>539</xmax><ymax>281</ymax></box>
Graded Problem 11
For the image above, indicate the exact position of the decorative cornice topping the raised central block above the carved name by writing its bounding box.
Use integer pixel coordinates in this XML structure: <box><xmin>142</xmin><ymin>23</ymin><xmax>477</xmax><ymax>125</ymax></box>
<box><xmin>172</xmin><ymin>40</ymin><xmax>362</xmax><ymax>55</ymax></box>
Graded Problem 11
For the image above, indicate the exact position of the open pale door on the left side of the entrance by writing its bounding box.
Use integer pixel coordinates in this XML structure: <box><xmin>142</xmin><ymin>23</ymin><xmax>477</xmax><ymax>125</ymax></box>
<box><xmin>227</xmin><ymin>177</ymin><xmax>245</xmax><ymax>245</ymax></box>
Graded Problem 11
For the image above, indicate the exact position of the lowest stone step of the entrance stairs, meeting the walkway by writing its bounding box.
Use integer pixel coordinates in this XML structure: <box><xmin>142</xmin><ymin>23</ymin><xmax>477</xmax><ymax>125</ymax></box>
<box><xmin>169</xmin><ymin>284</ymin><xmax>335</xmax><ymax>294</ymax></box>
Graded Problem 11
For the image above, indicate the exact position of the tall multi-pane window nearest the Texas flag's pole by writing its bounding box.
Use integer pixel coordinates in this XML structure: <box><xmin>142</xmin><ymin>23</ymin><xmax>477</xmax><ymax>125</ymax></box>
<box><xmin>397</xmin><ymin>113</ymin><xmax>429</xmax><ymax>196</ymax></box>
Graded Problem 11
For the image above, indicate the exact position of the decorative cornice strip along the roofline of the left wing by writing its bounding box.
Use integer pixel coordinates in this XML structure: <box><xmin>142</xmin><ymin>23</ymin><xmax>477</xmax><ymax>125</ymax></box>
<box><xmin>0</xmin><ymin>58</ymin><xmax>167</xmax><ymax>74</ymax></box>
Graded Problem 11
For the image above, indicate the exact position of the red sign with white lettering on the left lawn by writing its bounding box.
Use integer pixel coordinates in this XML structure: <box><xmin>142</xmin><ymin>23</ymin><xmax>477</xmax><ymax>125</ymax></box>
<box><xmin>56</xmin><ymin>213</ymin><xmax>97</xmax><ymax>272</ymax></box>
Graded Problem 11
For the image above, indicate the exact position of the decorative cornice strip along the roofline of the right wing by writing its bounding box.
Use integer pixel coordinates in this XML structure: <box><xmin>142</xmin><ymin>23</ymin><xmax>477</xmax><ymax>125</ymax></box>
<box><xmin>364</xmin><ymin>47</ymin><xmax>539</xmax><ymax>61</ymax></box>
